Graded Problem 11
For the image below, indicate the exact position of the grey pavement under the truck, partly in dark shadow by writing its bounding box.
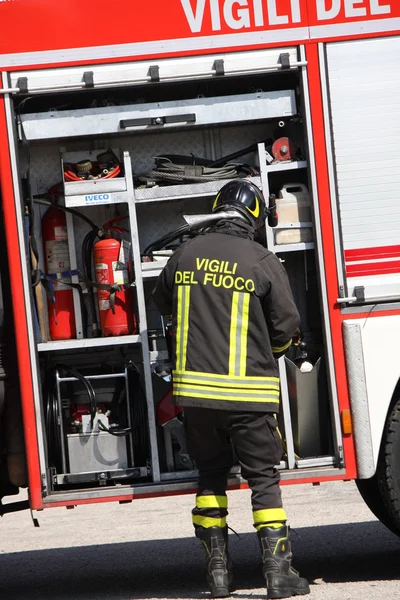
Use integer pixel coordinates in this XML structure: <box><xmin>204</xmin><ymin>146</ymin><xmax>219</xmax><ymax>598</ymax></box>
<box><xmin>0</xmin><ymin>482</ymin><xmax>400</xmax><ymax>600</ymax></box>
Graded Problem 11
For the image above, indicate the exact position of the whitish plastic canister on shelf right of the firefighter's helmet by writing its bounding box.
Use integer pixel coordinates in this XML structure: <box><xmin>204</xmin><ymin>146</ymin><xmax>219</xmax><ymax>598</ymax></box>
<box><xmin>275</xmin><ymin>183</ymin><xmax>313</xmax><ymax>244</ymax></box>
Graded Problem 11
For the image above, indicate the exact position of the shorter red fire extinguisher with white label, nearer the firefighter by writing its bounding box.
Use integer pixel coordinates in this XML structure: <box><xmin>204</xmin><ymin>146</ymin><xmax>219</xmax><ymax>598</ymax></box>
<box><xmin>93</xmin><ymin>233</ymin><xmax>136</xmax><ymax>337</ymax></box>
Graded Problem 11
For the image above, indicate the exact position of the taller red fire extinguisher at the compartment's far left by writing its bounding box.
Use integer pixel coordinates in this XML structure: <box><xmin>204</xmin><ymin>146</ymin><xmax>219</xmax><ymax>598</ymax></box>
<box><xmin>42</xmin><ymin>206</ymin><xmax>76</xmax><ymax>340</ymax></box>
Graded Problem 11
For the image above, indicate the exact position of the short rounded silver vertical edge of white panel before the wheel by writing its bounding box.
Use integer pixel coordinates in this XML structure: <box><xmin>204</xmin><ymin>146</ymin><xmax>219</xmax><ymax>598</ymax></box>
<box><xmin>343</xmin><ymin>322</ymin><xmax>375</xmax><ymax>479</ymax></box>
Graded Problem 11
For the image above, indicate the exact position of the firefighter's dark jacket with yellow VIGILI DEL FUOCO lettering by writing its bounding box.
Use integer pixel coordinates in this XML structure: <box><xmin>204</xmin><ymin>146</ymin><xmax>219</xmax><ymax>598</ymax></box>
<box><xmin>153</xmin><ymin>220</ymin><xmax>299</xmax><ymax>412</ymax></box>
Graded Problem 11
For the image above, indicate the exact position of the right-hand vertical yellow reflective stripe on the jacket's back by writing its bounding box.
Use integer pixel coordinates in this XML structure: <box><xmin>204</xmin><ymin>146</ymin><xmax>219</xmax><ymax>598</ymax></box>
<box><xmin>229</xmin><ymin>292</ymin><xmax>250</xmax><ymax>377</ymax></box>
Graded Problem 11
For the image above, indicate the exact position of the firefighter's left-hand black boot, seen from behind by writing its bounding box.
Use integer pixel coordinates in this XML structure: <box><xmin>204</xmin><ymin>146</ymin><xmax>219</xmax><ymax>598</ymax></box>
<box><xmin>196</xmin><ymin>527</ymin><xmax>234</xmax><ymax>598</ymax></box>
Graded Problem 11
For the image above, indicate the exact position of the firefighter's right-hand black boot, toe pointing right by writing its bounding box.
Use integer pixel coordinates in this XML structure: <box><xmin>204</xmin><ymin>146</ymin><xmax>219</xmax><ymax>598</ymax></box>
<box><xmin>257</xmin><ymin>525</ymin><xmax>310</xmax><ymax>598</ymax></box>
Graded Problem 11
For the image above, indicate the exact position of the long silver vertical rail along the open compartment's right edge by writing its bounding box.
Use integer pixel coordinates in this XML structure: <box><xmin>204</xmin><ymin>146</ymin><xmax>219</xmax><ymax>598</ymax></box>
<box><xmin>300</xmin><ymin>46</ymin><xmax>343</xmax><ymax>464</ymax></box>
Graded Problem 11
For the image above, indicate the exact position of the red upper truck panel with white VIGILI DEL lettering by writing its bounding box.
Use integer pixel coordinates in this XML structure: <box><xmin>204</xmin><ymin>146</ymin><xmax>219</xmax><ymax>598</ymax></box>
<box><xmin>0</xmin><ymin>0</ymin><xmax>400</xmax><ymax>68</ymax></box>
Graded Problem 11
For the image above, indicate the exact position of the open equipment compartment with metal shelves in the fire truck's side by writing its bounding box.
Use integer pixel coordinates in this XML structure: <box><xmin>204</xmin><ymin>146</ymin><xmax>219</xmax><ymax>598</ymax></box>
<box><xmin>8</xmin><ymin>49</ymin><xmax>342</xmax><ymax>500</ymax></box>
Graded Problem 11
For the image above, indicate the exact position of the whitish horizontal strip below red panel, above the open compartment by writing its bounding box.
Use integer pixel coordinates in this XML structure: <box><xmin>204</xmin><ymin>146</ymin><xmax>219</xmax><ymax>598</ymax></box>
<box><xmin>0</xmin><ymin>27</ymin><xmax>309</xmax><ymax>67</ymax></box>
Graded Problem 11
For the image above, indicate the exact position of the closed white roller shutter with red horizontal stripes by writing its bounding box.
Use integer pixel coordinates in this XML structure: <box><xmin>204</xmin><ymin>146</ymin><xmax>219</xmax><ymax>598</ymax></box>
<box><xmin>326</xmin><ymin>37</ymin><xmax>400</xmax><ymax>300</ymax></box>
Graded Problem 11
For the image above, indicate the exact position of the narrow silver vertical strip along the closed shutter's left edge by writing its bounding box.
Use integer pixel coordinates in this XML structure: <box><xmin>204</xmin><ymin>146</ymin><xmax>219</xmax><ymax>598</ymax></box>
<box><xmin>318</xmin><ymin>44</ymin><xmax>346</xmax><ymax>290</ymax></box>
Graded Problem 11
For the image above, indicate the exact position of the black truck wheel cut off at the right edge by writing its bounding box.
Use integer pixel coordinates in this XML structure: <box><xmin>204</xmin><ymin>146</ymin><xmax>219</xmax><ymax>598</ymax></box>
<box><xmin>356</xmin><ymin>400</ymin><xmax>400</xmax><ymax>536</ymax></box>
